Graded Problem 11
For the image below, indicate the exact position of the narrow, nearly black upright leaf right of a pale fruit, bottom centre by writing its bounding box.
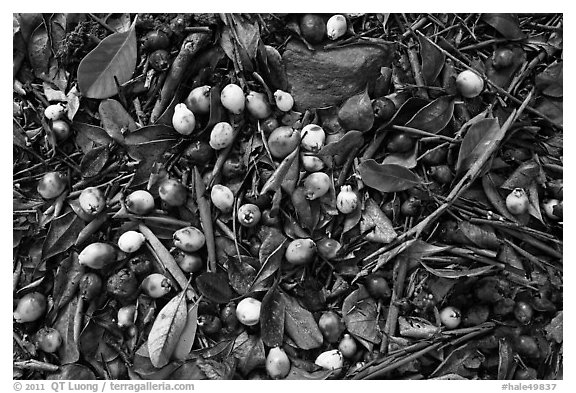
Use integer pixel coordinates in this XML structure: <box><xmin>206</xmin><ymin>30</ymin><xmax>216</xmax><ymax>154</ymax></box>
<box><xmin>260</xmin><ymin>286</ymin><xmax>286</xmax><ymax>347</ymax></box>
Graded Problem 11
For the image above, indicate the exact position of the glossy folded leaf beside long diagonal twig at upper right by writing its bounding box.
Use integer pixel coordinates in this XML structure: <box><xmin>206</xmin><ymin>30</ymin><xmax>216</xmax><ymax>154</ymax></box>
<box><xmin>456</xmin><ymin>119</ymin><xmax>500</xmax><ymax>174</ymax></box>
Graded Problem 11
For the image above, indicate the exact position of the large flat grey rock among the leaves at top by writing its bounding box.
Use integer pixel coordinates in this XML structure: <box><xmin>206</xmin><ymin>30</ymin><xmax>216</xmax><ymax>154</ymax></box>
<box><xmin>282</xmin><ymin>40</ymin><xmax>394</xmax><ymax>111</ymax></box>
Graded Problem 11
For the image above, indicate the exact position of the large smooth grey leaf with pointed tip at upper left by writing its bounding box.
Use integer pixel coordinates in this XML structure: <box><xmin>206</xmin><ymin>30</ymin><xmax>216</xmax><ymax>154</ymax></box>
<box><xmin>78</xmin><ymin>21</ymin><xmax>138</xmax><ymax>99</ymax></box>
